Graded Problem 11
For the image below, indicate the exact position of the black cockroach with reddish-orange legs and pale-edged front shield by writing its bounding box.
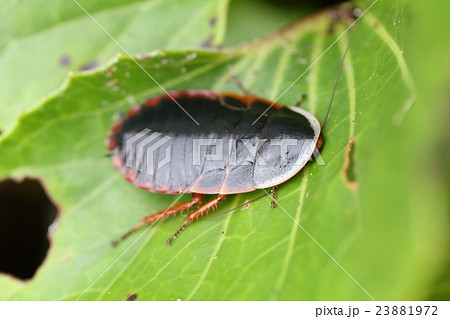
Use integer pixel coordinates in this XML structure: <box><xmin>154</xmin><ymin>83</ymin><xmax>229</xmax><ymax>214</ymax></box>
<box><xmin>106</xmin><ymin>15</ymin><xmax>356</xmax><ymax>246</ymax></box>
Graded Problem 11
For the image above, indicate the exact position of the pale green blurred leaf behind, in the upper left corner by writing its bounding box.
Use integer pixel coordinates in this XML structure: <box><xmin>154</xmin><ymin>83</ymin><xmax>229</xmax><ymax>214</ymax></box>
<box><xmin>0</xmin><ymin>0</ymin><xmax>227</xmax><ymax>132</ymax></box>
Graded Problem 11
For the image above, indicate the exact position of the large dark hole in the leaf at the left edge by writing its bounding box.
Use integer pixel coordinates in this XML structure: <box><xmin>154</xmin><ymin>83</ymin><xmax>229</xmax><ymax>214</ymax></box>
<box><xmin>0</xmin><ymin>178</ymin><xmax>58</xmax><ymax>279</ymax></box>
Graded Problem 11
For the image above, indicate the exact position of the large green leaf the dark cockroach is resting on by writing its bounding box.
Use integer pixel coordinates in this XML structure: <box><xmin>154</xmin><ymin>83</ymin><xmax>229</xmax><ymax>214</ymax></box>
<box><xmin>0</xmin><ymin>0</ymin><xmax>448</xmax><ymax>300</ymax></box>
